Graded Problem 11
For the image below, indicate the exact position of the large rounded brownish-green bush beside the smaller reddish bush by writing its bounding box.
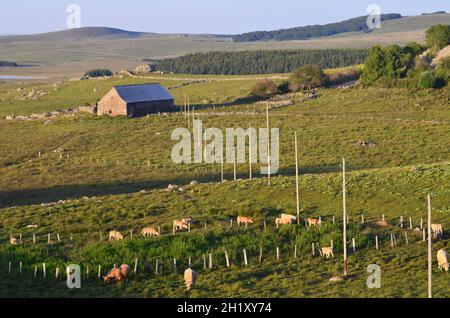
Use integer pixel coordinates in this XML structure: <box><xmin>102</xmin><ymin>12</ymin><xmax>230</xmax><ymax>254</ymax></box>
<box><xmin>289</xmin><ymin>64</ymin><xmax>327</xmax><ymax>92</ymax></box>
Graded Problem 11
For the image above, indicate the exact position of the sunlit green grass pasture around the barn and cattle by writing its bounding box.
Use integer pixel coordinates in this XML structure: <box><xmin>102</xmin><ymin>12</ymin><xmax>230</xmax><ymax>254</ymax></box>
<box><xmin>0</xmin><ymin>71</ymin><xmax>450</xmax><ymax>297</ymax></box>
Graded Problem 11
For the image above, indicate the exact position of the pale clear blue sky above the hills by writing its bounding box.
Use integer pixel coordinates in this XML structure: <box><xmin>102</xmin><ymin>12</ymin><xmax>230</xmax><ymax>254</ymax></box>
<box><xmin>0</xmin><ymin>0</ymin><xmax>450</xmax><ymax>35</ymax></box>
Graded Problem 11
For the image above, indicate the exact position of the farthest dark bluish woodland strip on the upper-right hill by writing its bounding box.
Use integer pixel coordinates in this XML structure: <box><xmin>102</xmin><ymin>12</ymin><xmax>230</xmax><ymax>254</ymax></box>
<box><xmin>232</xmin><ymin>13</ymin><xmax>402</xmax><ymax>42</ymax></box>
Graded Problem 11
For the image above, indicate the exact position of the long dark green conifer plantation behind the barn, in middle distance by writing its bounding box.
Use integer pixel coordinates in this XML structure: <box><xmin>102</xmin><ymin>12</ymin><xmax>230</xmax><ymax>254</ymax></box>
<box><xmin>152</xmin><ymin>49</ymin><xmax>368</xmax><ymax>75</ymax></box>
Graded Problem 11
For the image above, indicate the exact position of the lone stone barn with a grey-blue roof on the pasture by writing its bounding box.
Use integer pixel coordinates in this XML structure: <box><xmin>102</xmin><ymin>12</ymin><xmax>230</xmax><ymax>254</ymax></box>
<box><xmin>97</xmin><ymin>83</ymin><xmax>177</xmax><ymax>117</ymax></box>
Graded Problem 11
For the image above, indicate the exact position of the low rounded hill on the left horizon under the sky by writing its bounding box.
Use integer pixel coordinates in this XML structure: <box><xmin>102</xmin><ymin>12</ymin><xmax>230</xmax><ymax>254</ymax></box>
<box><xmin>0</xmin><ymin>27</ymin><xmax>150</xmax><ymax>41</ymax></box>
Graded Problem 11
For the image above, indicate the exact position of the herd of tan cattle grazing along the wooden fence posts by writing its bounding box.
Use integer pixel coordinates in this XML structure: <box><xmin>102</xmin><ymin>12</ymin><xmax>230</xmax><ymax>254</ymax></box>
<box><xmin>5</xmin><ymin>214</ymin><xmax>450</xmax><ymax>290</ymax></box>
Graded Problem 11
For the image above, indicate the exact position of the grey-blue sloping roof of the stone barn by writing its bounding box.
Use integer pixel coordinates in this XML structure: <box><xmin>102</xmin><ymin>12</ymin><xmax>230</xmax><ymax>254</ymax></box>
<box><xmin>115</xmin><ymin>83</ymin><xmax>173</xmax><ymax>103</ymax></box>
